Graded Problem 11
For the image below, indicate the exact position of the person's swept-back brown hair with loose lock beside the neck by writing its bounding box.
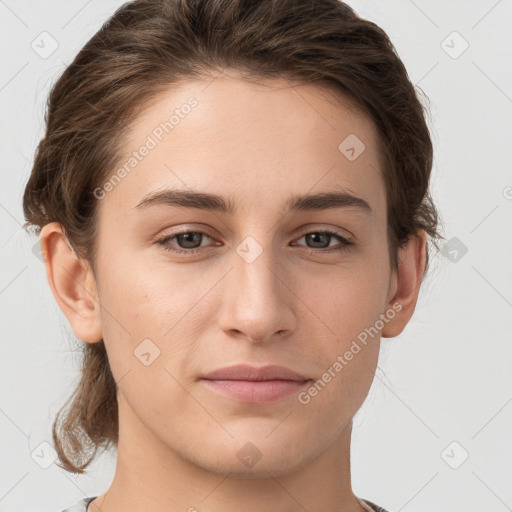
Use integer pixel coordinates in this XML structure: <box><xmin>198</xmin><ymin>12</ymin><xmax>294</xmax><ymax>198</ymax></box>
<box><xmin>23</xmin><ymin>0</ymin><xmax>443</xmax><ymax>473</ymax></box>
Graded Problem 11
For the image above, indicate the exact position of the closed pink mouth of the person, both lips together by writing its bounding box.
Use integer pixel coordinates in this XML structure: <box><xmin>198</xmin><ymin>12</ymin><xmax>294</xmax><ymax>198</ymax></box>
<box><xmin>201</xmin><ymin>365</ymin><xmax>311</xmax><ymax>404</ymax></box>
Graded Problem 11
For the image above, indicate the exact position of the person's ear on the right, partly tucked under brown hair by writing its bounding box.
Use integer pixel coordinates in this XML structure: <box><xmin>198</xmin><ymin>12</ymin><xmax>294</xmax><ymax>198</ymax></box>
<box><xmin>381</xmin><ymin>229</ymin><xmax>427</xmax><ymax>338</ymax></box>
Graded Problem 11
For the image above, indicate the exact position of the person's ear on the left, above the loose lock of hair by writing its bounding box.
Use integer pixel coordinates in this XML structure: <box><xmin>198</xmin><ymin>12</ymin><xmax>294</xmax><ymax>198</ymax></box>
<box><xmin>40</xmin><ymin>222</ymin><xmax>103</xmax><ymax>343</ymax></box>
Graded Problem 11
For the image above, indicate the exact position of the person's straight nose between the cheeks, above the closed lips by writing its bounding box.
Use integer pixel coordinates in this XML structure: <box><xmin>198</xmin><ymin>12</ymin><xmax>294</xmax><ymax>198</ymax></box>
<box><xmin>219</xmin><ymin>240</ymin><xmax>297</xmax><ymax>343</ymax></box>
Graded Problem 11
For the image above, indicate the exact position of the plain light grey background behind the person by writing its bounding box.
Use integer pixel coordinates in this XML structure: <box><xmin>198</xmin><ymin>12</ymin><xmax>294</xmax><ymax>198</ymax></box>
<box><xmin>0</xmin><ymin>0</ymin><xmax>512</xmax><ymax>512</ymax></box>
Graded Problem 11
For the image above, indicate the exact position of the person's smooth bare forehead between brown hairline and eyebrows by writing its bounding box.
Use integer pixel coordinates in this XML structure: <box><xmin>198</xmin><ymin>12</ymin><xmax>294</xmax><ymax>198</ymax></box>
<box><xmin>97</xmin><ymin>75</ymin><xmax>385</xmax><ymax>217</ymax></box>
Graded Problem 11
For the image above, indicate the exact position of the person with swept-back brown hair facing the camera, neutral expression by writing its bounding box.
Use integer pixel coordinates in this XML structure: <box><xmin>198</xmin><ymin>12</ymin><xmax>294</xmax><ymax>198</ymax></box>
<box><xmin>23</xmin><ymin>0</ymin><xmax>441</xmax><ymax>512</ymax></box>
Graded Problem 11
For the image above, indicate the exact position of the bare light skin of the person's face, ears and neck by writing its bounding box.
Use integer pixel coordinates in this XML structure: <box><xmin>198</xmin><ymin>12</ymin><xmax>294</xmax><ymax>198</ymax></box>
<box><xmin>41</xmin><ymin>73</ymin><xmax>426</xmax><ymax>512</ymax></box>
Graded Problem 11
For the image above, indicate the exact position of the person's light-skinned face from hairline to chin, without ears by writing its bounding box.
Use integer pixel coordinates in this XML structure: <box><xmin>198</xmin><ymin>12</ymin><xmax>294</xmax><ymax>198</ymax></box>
<box><xmin>48</xmin><ymin>75</ymin><xmax>410</xmax><ymax>476</ymax></box>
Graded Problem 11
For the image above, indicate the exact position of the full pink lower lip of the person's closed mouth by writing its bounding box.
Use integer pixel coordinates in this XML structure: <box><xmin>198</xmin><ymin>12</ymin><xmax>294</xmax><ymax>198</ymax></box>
<box><xmin>203</xmin><ymin>379</ymin><xmax>309</xmax><ymax>404</ymax></box>
